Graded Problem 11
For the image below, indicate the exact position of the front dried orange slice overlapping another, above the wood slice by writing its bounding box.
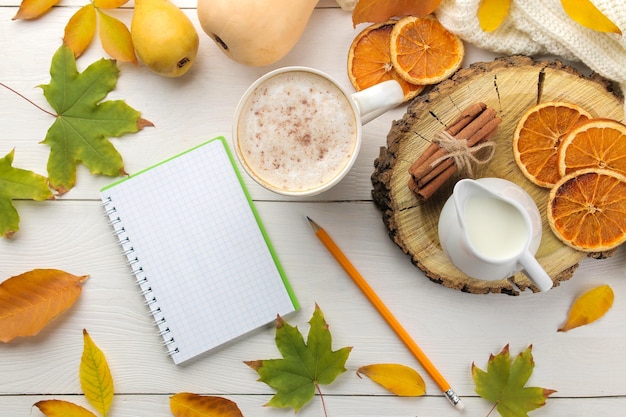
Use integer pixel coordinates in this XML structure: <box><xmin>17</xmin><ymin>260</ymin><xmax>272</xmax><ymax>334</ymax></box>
<box><xmin>391</xmin><ymin>16</ymin><xmax>465</xmax><ymax>84</ymax></box>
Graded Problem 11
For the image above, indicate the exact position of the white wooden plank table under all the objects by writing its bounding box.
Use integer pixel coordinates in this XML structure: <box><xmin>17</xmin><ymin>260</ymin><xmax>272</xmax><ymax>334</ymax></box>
<box><xmin>0</xmin><ymin>0</ymin><xmax>626</xmax><ymax>417</ymax></box>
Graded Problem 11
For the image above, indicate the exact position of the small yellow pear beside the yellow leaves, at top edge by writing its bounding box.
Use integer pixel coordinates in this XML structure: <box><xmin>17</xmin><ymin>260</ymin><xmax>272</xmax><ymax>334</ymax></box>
<box><xmin>130</xmin><ymin>0</ymin><xmax>199</xmax><ymax>77</ymax></box>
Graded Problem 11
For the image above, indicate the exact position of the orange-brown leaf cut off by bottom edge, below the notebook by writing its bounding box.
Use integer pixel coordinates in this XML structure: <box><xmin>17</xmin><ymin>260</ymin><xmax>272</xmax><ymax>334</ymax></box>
<box><xmin>170</xmin><ymin>392</ymin><xmax>243</xmax><ymax>417</ymax></box>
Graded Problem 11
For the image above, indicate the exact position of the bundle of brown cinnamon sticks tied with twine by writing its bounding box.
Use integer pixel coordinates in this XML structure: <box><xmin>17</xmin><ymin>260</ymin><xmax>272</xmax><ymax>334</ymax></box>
<box><xmin>409</xmin><ymin>103</ymin><xmax>501</xmax><ymax>200</ymax></box>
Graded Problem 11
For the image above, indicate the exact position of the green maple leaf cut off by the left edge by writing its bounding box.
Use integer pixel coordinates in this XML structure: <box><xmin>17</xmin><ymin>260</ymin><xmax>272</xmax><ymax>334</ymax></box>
<box><xmin>0</xmin><ymin>150</ymin><xmax>53</xmax><ymax>237</ymax></box>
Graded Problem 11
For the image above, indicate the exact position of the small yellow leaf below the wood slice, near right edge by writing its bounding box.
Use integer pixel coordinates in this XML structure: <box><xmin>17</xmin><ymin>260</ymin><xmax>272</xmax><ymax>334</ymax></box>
<box><xmin>558</xmin><ymin>285</ymin><xmax>615</xmax><ymax>332</ymax></box>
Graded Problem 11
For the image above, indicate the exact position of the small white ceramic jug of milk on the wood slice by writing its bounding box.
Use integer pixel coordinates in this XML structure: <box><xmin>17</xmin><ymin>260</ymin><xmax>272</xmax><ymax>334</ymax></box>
<box><xmin>439</xmin><ymin>178</ymin><xmax>553</xmax><ymax>291</ymax></box>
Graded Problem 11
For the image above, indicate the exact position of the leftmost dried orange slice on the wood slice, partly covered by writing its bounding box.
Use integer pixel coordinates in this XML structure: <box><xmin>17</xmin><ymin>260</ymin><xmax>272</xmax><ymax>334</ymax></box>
<box><xmin>513</xmin><ymin>101</ymin><xmax>591</xmax><ymax>188</ymax></box>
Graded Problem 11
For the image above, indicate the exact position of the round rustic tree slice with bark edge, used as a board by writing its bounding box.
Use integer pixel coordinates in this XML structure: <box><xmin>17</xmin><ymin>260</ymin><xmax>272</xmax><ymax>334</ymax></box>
<box><xmin>372</xmin><ymin>56</ymin><xmax>624</xmax><ymax>295</ymax></box>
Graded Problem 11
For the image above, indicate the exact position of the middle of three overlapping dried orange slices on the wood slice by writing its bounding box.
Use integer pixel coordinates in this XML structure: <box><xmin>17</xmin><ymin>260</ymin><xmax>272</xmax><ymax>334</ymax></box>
<box><xmin>558</xmin><ymin>119</ymin><xmax>626</xmax><ymax>176</ymax></box>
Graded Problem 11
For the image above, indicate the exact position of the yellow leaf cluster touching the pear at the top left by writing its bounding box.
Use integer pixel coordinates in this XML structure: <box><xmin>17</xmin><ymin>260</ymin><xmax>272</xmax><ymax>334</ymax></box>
<box><xmin>63</xmin><ymin>0</ymin><xmax>137</xmax><ymax>64</ymax></box>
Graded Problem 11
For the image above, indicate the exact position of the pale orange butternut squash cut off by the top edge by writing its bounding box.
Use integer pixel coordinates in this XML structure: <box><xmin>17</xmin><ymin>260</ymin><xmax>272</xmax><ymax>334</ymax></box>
<box><xmin>198</xmin><ymin>0</ymin><xmax>318</xmax><ymax>66</ymax></box>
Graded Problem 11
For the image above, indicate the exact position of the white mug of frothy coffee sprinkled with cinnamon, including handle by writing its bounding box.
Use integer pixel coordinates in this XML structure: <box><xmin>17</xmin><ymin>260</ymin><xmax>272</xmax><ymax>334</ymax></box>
<box><xmin>233</xmin><ymin>67</ymin><xmax>404</xmax><ymax>196</ymax></box>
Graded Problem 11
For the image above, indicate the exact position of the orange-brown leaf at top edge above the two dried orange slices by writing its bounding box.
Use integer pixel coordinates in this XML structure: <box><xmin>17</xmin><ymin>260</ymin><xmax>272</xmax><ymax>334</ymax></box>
<box><xmin>352</xmin><ymin>0</ymin><xmax>441</xmax><ymax>26</ymax></box>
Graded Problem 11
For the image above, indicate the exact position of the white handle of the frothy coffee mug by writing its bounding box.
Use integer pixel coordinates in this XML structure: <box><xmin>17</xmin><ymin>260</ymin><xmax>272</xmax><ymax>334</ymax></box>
<box><xmin>352</xmin><ymin>80</ymin><xmax>404</xmax><ymax>124</ymax></box>
